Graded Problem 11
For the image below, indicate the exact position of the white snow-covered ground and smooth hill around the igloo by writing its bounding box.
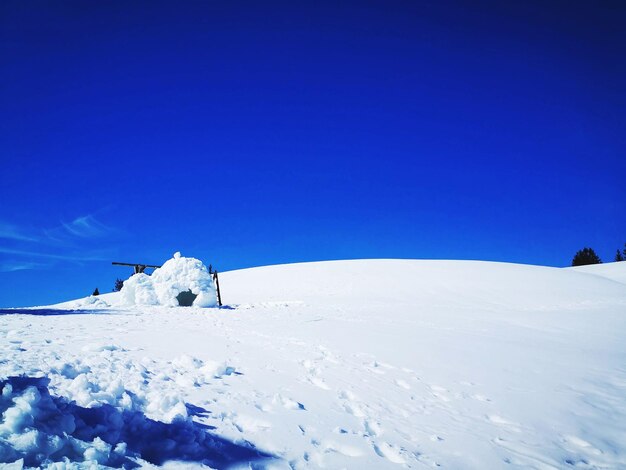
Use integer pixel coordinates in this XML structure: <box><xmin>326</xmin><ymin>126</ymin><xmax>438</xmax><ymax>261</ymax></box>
<box><xmin>0</xmin><ymin>260</ymin><xmax>626</xmax><ymax>469</ymax></box>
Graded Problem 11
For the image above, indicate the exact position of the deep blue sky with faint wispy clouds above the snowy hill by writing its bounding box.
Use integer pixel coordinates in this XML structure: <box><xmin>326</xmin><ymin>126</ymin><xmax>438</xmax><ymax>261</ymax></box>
<box><xmin>0</xmin><ymin>0</ymin><xmax>626</xmax><ymax>306</ymax></box>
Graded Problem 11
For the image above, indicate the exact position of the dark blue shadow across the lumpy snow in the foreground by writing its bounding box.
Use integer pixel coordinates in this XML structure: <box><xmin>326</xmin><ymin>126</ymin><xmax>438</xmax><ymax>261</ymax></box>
<box><xmin>0</xmin><ymin>377</ymin><xmax>275</xmax><ymax>469</ymax></box>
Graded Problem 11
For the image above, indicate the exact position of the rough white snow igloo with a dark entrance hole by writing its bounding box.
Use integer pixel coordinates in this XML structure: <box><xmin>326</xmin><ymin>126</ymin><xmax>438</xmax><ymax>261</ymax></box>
<box><xmin>121</xmin><ymin>252</ymin><xmax>217</xmax><ymax>307</ymax></box>
